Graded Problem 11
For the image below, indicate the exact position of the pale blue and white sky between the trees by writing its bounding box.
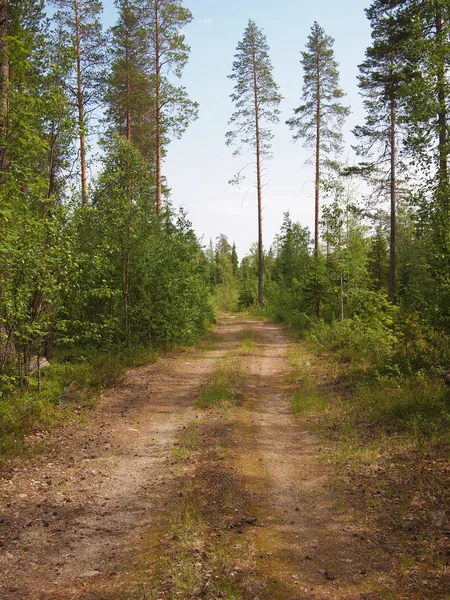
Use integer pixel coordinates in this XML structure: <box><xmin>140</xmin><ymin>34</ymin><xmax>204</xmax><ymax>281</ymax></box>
<box><xmin>104</xmin><ymin>0</ymin><xmax>371</xmax><ymax>257</ymax></box>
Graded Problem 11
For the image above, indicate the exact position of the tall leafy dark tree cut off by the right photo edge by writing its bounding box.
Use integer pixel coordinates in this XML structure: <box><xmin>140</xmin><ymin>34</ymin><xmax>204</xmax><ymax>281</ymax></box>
<box><xmin>396</xmin><ymin>0</ymin><xmax>450</xmax><ymax>312</ymax></box>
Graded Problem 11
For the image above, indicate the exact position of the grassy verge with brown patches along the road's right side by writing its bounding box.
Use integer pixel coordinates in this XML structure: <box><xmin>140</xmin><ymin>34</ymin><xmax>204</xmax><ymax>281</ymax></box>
<box><xmin>288</xmin><ymin>328</ymin><xmax>450</xmax><ymax>600</ymax></box>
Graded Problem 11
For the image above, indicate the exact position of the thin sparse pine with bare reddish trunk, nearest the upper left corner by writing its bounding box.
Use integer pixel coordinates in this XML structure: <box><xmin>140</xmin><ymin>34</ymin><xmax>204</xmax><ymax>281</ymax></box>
<box><xmin>53</xmin><ymin>0</ymin><xmax>105</xmax><ymax>205</ymax></box>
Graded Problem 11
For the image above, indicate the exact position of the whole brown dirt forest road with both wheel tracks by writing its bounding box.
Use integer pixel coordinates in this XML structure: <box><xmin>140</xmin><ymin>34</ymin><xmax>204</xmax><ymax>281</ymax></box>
<box><xmin>0</xmin><ymin>315</ymin><xmax>385</xmax><ymax>600</ymax></box>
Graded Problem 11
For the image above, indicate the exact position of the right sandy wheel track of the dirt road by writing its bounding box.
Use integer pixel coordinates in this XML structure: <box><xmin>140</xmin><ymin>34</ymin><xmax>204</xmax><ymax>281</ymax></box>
<box><xmin>232</xmin><ymin>323</ymin><xmax>389</xmax><ymax>600</ymax></box>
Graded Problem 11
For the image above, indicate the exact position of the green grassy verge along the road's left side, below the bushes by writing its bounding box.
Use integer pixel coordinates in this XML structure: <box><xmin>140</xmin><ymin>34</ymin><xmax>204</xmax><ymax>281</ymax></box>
<box><xmin>0</xmin><ymin>348</ymin><xmax>155</xmax><ymax>459</ymax></box>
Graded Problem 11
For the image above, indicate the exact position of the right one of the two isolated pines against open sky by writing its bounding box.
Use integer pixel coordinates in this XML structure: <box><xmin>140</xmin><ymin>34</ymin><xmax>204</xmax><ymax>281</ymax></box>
<box><xmin>287</xmin><ymin>22</ymin><xmax>350</xmax><ymax>255</ymax></box>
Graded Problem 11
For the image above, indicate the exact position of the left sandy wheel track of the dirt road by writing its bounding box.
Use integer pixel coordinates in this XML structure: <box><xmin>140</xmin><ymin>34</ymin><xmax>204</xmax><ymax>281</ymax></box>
<box><xmin>0</xmin><ymin>324</ymin><xmax>243</xmax><ymax>600</ymax></box>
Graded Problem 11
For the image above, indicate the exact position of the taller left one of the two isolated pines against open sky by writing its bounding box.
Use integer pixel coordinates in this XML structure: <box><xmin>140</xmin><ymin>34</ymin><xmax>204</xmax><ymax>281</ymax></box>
<box><xmin>227</xmin><ymin>20</ymin><xmax>281</xmax><ymax>306</ymax></box>
